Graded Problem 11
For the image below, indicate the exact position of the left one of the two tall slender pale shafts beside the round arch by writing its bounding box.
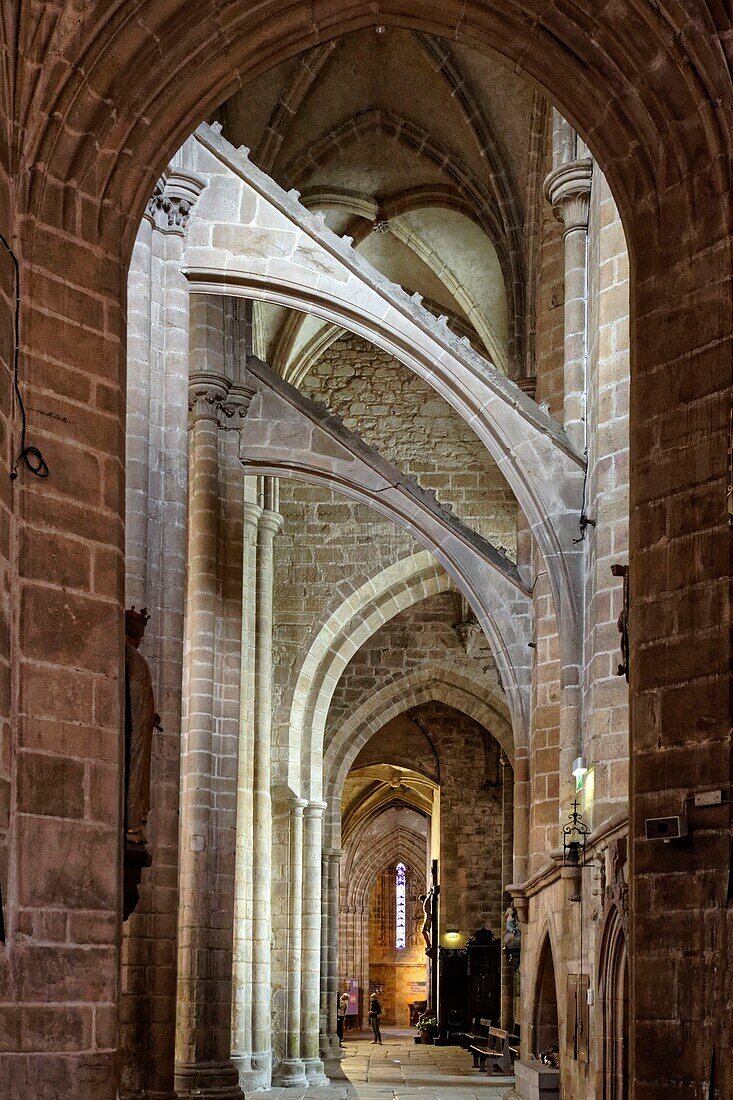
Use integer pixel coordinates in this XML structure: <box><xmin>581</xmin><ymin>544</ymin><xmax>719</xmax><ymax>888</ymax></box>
<box><xmin>232</xmin><ymin>495</ymin><xmax>263</xmax><ymax>1091</ymax></box>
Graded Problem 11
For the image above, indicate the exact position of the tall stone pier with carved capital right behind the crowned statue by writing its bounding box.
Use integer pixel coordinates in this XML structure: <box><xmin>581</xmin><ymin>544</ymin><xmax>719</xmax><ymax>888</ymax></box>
<box><xmin>118</xmin><ymin>168</ymin><xmax>204</xmax><ymax>1100</ymax></box>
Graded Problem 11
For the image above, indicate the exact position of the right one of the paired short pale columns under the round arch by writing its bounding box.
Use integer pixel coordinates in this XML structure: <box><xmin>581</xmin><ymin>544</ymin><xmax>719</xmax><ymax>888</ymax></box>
<box><xmin>300</xmin><ymin>802</ymin><xmax>328</xmax><ymax>1086</ymax></box>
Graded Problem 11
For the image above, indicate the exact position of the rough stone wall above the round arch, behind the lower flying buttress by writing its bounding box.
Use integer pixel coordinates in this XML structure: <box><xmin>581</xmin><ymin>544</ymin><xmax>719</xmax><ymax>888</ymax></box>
<box><xmin>274</xmin><ymin>334</ymin><xmax>516</xmax><ymax>783</ymax></box>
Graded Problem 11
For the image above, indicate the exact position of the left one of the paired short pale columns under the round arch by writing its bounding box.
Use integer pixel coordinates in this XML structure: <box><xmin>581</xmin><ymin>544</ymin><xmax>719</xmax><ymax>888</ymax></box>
<box><xmin>273</xmin><ymin>798</ymin><xmax>308</xmax><ymax>1088</ymax></box>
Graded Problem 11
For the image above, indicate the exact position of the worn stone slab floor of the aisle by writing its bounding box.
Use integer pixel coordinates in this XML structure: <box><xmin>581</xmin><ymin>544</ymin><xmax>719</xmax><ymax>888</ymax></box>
<box><xmin>259</xmin><ymin>1027</ymin><xmax>514</xmax><ymax>1100</ymax></box>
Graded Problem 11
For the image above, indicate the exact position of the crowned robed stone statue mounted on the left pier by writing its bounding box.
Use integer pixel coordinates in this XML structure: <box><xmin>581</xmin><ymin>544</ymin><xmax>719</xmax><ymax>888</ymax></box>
<box><xmin>124</xmin><ymin>607</ymin><xmax>163</xmax><ymax>846</ymax></box>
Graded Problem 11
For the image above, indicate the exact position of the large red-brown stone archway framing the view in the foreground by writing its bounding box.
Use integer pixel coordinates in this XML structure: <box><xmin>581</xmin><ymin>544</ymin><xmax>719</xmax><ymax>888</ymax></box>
<box><xmin>0</xmin><ymin>0</ymin><xmax>733</xmax><ymax>1100</ymax></box>
